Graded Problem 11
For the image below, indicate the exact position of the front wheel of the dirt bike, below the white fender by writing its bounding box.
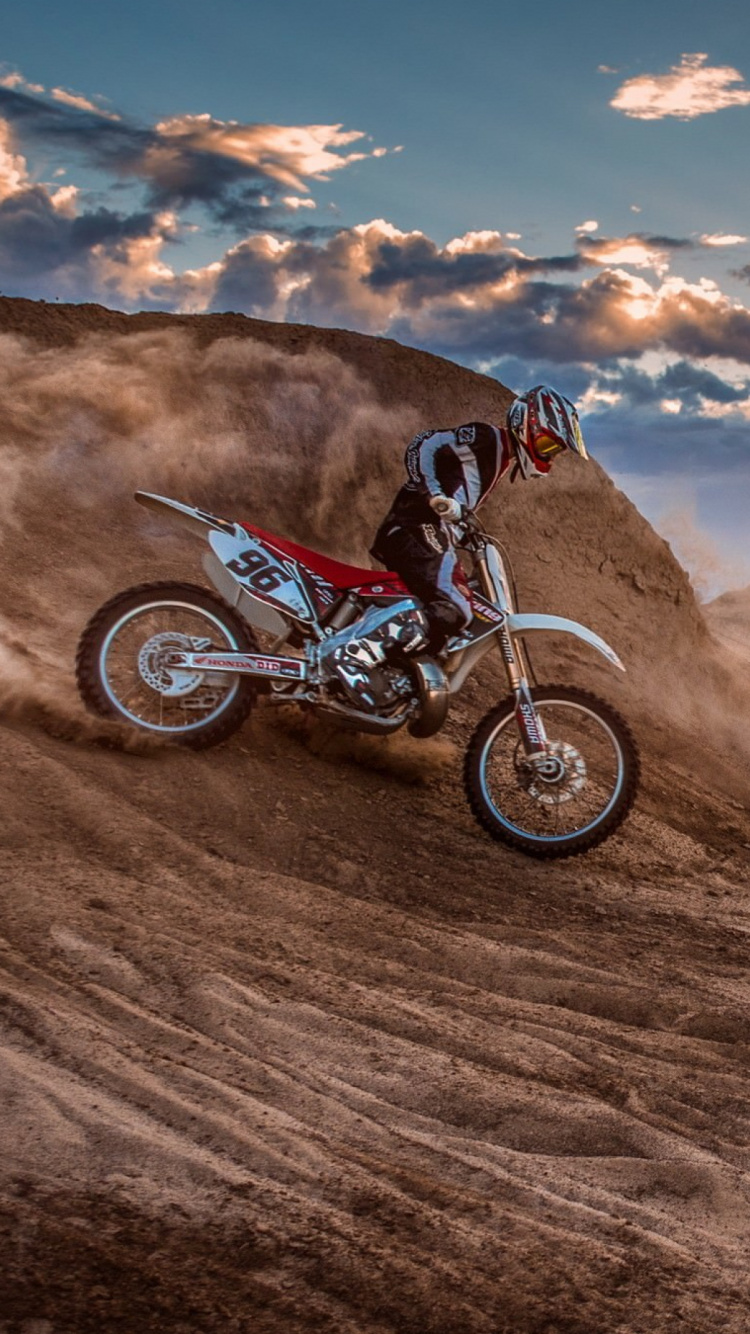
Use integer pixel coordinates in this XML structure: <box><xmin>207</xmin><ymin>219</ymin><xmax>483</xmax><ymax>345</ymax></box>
<box><xmin>464</xmin><ymin>686</ymin><xmax>632</xmax><ymax>858</ymax></box>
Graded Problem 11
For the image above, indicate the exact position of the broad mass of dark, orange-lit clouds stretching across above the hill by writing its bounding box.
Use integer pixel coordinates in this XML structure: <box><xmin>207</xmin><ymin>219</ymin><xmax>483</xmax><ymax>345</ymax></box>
<box><xmin>0</xmin><ymin>63</ymin><xmax>750</xmax><ymax>485</ymax></box>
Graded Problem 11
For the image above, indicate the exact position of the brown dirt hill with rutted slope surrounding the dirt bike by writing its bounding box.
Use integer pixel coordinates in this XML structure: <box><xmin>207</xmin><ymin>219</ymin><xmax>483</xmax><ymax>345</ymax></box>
<box><xmin>0</xmin><ymin>299</ymin><xmax>750</xmax><ymax>1334</ymax></box>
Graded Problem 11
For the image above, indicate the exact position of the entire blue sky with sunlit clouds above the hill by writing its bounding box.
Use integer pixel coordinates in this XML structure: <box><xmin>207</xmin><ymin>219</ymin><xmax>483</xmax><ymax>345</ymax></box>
<box><xmin>0</xmin><ymin>0</ymin><xmax>750</xmax><ymax>596</ymax></box>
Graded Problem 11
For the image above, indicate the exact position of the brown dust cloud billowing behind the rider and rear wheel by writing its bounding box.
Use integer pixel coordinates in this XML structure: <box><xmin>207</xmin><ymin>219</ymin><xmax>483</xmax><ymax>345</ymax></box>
<box><xmin>0</xmin><ymin>329</ymin><xmax>414</xmax><ymax>739</ymax></box>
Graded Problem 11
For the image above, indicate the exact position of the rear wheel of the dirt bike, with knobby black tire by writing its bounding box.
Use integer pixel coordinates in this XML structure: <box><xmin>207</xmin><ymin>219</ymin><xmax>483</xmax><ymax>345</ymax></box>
<box><xmin>76</xmin><ymin>583</ymin><xmax>258</xmax><ymax>750</ymax></box>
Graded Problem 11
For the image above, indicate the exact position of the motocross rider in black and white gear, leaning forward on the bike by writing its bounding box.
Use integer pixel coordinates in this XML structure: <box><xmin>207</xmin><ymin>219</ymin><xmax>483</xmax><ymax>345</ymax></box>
<box><xmin>335</xmin><ymin>384</ymin><xmax>589</xmax><ymax>707</ymax></box>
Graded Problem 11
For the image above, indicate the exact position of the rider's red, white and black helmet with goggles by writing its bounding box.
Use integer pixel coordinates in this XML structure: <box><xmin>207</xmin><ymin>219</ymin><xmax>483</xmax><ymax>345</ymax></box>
<box><xmin>506</xmin><ymin>384</ymin><xmax>589</xmax><ymax>479</ymax></box>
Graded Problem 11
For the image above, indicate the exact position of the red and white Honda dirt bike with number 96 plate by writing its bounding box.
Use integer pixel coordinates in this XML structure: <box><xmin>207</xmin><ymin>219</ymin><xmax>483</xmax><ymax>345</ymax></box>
<box><xmin>76</xmin><ymin>491</ymin><xmax>639</xmax><ymax>858</ymax></box>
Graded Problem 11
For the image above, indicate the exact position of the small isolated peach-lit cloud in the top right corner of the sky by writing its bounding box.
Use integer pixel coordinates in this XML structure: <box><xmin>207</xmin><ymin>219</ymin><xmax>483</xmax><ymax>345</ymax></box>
<box><xmin>610</xmin><ymin>53</ymin><xmax>750</xmax><ymax>120</ymax></box>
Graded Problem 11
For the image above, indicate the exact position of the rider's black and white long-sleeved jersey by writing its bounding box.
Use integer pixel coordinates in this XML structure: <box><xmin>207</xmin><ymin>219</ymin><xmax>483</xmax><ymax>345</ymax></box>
<box><xmin>388</xmin><ymin>422</ymin><xmax>503</xmax><ymax>523</ymax></box>
